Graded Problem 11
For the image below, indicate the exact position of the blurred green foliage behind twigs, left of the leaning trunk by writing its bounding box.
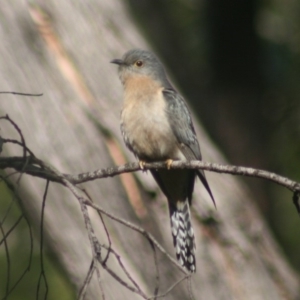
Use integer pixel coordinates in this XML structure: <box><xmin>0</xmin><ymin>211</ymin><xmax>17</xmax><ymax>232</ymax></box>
<box><xmin>0</xmin><ymin>182</ymin><xmax>76</xmax><ymax>300</ymax></box>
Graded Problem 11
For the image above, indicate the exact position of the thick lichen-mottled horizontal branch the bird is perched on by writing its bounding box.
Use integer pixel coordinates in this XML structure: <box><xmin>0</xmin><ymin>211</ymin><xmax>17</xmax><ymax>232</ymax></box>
<box><xmin>0</xmin><ymin>156</ymin><xmax>300</xmax><ymax>193</ymax></box>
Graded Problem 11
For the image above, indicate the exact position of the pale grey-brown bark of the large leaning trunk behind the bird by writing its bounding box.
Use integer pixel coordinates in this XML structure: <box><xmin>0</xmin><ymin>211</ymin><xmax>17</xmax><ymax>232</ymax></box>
<box><xmin>0</xmin><ymin>0</ymin><xmax>300</xmax><ymax>300</ymax></box>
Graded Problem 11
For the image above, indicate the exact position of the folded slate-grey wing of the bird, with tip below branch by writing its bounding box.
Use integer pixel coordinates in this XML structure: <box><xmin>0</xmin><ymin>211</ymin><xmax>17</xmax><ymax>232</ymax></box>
<box><xmin>163</xmin><ymin>89</ymin><xmax>216</xmax><ymax>206</ymax></box>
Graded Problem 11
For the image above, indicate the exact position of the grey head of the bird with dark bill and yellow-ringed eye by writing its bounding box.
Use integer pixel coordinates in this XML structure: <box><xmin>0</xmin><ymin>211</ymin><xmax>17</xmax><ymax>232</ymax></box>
<box><xmin>111</xmin><ymin>49</ymin><xmax>171</xmax><ymax>87</ymax></box>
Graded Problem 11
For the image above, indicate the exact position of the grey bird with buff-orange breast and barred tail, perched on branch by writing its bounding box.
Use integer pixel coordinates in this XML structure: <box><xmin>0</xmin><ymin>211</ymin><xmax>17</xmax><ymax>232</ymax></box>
<box><xmin>111</xmin><ymin>49</ymin><xmax>215</xmax><ymax>273</ymax></box>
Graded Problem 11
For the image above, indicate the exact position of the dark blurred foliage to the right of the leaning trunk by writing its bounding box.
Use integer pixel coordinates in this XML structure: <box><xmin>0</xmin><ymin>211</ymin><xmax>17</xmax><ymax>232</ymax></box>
<box><xmin>128</xmin><ymin>0</ymin><xmax>300</xmax><ymax>270</ymax></box>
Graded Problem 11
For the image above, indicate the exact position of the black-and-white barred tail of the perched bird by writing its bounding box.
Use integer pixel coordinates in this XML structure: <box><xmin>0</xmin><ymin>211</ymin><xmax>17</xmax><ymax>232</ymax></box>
<box><xmin>170</xmin><ymin>200</ymin><xmax>196</xmax><ymax>272</ymax></box>
